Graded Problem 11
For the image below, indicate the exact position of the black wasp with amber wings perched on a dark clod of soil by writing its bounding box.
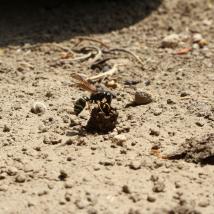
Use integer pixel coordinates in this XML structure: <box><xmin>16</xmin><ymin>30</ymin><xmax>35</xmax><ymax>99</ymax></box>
<box><xmin>72</xmin><ymin>74</ymin><xmax>114</xmax><ymax>115</ymax></box>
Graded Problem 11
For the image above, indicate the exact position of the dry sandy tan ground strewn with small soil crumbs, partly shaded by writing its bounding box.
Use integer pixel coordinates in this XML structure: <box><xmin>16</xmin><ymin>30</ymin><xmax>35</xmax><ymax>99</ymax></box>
<box><xmin>0</xmin><ymin>0</ymin><xmax>214</xmax><ymax>214</ymax></box>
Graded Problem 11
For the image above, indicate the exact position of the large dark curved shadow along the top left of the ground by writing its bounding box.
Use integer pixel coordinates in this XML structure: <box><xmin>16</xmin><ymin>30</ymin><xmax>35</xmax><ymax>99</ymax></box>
<box><xmin>0</xmin><ymin>0</ymin><xmax>162</xmax><ymax>47</ymax></box>
